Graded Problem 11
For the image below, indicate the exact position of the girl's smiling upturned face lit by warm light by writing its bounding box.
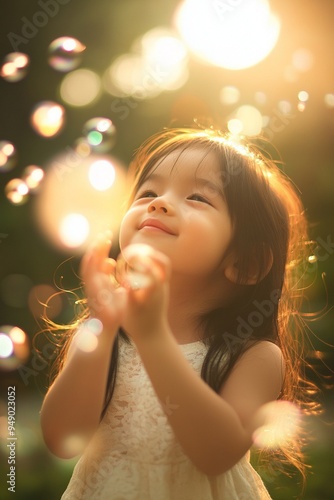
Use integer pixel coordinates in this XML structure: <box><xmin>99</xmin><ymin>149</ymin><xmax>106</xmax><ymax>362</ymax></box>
<box><xmin>120</xmin><ymin>147</ymin><xmax>232</xmax><ymax>277</ymax></box>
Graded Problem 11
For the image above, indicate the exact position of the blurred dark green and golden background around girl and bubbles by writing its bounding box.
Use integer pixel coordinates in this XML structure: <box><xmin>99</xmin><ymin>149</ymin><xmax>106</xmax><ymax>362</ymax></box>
<box><xmin>0</xmin><ymin>0</ymin><xmax>334</xmax><ymax>500</ymax></box>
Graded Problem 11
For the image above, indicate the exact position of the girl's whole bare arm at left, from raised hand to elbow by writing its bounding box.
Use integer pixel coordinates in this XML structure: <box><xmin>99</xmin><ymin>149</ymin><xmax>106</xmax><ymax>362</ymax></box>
<box><xmin>41</xmin><ymin>238</ymin><xmax>125</xmax><ymax>458</ymax></box>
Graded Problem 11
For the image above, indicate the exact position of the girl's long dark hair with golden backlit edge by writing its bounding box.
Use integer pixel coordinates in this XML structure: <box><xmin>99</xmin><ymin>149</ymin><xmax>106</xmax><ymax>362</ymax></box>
<box><xmin>48</xmin><ymin>128</ymin><xmax>316</xmax><ymax>484</ymax></box>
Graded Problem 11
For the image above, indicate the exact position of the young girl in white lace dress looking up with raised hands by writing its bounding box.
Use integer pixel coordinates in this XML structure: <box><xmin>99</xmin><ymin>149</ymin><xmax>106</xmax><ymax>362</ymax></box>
<box><xmin>41</xmin><ymin>129</ymin><xmax>318</xmax><ymax>500</ymax></box>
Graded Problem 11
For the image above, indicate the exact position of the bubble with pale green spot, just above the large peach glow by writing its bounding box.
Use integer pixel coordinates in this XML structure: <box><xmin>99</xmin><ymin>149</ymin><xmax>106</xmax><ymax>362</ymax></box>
<box><xmin>83</xmin><ymin>117</ymin><xmax>116</xmax><ymax>153</ymax></box>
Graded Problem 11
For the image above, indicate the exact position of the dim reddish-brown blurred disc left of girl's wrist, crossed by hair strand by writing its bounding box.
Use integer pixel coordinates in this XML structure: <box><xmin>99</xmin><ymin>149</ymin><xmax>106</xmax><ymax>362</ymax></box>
<box><xmin>28</xmin><ymin>284</ymin><xmax>63</xmax><ymax>319</ymax></box>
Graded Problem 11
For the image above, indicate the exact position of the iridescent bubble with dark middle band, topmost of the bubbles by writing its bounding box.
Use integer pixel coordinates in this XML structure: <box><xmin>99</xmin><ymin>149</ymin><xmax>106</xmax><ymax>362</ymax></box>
<box><xmin>49</xmin><ymin>36</ymin><xmax>86</xmax><ymax>73</ymax></box>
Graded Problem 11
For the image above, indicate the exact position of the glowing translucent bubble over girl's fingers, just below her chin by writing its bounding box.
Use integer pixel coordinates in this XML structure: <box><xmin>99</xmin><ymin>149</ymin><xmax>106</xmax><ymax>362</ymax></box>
<box><xmin>115</xmin><ymin>243</ymin><xmax>157</xmax><ymax>290</ymax></box>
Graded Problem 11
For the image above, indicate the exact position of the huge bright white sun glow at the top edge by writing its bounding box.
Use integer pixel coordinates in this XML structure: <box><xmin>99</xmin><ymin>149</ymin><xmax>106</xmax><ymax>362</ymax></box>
<box><xmin>175</xmin><ymin>0</ymin><xmax>280</xmax><ymax>70</ymax></box>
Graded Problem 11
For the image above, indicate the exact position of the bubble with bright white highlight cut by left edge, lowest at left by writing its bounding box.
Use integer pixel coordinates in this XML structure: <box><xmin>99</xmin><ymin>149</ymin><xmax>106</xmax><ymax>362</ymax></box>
<box><xmin>0</xmin><ymin>325</ymin><xmax>29</xmax><ymax>370</ymax></box>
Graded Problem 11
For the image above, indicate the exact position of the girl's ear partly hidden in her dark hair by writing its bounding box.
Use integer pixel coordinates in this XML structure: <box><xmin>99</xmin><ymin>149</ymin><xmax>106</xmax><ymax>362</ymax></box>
<box><xmin>224</xmin><ymin>245</ymin><xmax>274</xmax><ymax>285</ymax></box>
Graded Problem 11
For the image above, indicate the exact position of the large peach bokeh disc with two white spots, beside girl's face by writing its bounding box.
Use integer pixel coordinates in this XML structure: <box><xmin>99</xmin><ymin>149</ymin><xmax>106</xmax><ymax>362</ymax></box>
<box><xmin>34</xmin><ymin>151</ymin><xmax>127</xmax><ymax>252</ymax></box>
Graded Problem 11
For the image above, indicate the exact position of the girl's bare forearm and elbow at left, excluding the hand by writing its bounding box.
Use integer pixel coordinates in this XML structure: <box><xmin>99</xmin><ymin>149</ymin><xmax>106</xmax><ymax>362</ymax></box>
<box><xmin>41</xmin><ymin>326</ymin><xmax>113</xmax><ymax>458</ymax></box>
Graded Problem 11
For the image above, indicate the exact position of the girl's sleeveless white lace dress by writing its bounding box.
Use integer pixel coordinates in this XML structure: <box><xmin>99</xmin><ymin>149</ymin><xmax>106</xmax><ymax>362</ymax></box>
<box><xmin>61</xmin><ymin>341</ymin><xmax>270</xmax><ymax>500</ymax></box>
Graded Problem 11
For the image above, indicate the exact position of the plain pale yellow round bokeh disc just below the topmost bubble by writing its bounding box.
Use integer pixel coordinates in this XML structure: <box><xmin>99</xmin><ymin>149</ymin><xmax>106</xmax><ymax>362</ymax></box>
<box><xmin>60</xmin><ymin>69</ymin><xmax>101</xmax><ymax>107</ymax></box>
